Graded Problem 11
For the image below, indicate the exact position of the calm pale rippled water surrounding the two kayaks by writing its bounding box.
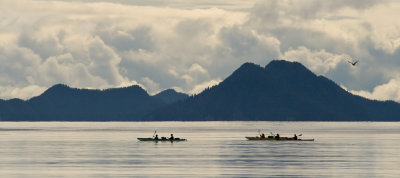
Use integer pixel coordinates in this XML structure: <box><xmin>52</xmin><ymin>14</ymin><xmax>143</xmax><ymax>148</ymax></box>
<box><xmin>0</xmin><ymin>122</ymin><xmax>400</xmax><ymax>177</ymax></box>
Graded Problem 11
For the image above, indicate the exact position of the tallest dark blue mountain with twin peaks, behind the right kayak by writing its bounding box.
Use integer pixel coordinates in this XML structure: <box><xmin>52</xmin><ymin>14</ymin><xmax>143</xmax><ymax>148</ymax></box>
<box><xmin>144</xmin><ymin>60</ymin><xmax>400</xmax><ymax>121</ymax></box>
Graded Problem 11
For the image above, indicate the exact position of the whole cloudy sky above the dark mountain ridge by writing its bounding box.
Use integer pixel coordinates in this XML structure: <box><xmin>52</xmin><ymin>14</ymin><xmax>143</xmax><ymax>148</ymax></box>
<box><xmin>0</xmin><ymin>0</ymin><xmax>400</xmax><ymax>102</ymax></box>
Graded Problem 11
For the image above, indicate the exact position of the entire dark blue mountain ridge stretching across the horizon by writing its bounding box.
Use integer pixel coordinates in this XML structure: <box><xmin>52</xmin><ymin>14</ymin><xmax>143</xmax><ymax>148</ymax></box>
<box><xmin>0</xmin><ymin>60</ymin><xmax>400</xmax><ymax>121</ymax></box>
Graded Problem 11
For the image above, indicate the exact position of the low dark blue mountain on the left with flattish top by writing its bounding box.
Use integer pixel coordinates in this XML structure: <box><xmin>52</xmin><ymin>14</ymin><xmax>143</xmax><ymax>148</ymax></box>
<box><xmin>0</xmin><ymin>84</ymin><xmax>165</xmax><ymax>121</ymax></box>
